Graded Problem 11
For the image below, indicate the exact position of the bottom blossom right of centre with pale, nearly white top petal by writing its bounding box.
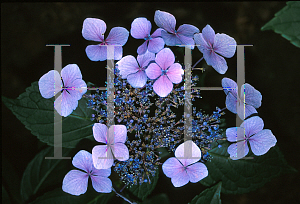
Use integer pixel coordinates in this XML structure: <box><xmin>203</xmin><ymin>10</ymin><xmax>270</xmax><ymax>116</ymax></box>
<box><xmin>162</xmin><ymin>140</ymin><xmax>208</xmax><ymax>187</ymax></box>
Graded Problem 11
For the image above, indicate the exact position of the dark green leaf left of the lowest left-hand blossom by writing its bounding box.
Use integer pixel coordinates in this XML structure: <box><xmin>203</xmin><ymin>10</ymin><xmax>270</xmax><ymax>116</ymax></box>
<box><xmin>21</xmin><ymin>147</ymin><xmax>74</xmax><ymax>201</ymax></box>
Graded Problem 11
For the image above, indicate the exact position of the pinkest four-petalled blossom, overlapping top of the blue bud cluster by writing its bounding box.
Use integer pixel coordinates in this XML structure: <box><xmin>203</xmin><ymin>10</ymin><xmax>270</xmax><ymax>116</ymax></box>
<box><xmin>146</xmin><ymin>48</ymin><xmax>184</xmax><ymax>97</ymax></box>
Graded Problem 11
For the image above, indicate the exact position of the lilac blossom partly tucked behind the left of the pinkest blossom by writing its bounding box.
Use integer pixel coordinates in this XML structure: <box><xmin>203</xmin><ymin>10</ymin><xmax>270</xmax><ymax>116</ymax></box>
<box><xmin>117</xmin><ymin>51</ymin><xmax>155</xmax><ymax>88</ymax></box>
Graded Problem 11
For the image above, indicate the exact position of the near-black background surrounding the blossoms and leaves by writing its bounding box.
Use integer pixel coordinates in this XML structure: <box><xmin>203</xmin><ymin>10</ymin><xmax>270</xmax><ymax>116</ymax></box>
<box><xmin>1</xmin><ymin>2</ymin><xmax>300</xmax><ymax>204</ymax></box>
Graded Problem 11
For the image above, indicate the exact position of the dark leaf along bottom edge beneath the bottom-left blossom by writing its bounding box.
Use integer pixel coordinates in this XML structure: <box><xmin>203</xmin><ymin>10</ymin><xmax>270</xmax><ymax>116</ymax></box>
<box><xmin>31</xmin><ymin>186</ymin><xmax>113</xmax><ymax>204</ymax></box>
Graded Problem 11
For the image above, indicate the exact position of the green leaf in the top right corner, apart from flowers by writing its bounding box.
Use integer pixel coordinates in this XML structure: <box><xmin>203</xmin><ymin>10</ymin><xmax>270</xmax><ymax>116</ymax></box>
<box><xmin>261</xmin><ymin>1</ymin><xmax>300</xmax><ymax>47</ymax></box>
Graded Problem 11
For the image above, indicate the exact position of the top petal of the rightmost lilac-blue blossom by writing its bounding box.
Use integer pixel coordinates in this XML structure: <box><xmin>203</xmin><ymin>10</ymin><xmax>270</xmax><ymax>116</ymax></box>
<box><xmin>241</xmin><ymin>116</ymin><xmax>264</xmax><ymax>137</ymax></box>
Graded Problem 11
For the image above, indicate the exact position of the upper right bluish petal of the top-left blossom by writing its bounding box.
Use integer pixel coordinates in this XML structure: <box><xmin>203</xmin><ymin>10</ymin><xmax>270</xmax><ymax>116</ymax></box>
<box><xmin>105</xmin><ymin>27</ymin><xmax>129</xmax><ymax>46</ymax></box>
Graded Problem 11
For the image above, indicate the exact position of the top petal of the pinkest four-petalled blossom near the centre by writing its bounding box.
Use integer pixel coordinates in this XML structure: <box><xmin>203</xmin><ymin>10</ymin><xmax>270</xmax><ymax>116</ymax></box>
<box><xmin>155</xmin><ymin>48</ymin><xmax>175</xmax><ymax>70</ymax></box>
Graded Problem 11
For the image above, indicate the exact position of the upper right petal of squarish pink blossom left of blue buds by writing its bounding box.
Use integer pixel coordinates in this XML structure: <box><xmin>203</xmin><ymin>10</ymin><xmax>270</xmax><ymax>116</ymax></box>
<box><xmin>108</xmin><ymin>125</ymin><xmax>127</xmax><ymax>144</ymax></box>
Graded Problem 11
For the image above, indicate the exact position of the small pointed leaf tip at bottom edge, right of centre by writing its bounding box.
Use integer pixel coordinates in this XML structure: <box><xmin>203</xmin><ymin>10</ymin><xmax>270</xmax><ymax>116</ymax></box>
<box><xmin>190</xmin><ymin>182</ymin><xmax>222</xmax><ymax>204</ymax></box>
